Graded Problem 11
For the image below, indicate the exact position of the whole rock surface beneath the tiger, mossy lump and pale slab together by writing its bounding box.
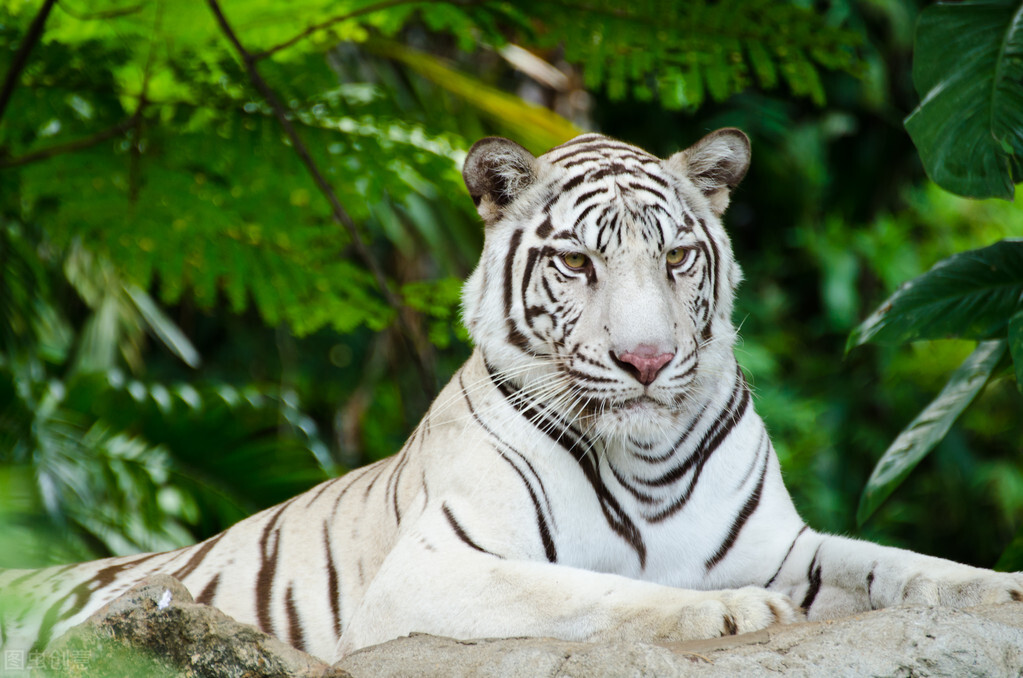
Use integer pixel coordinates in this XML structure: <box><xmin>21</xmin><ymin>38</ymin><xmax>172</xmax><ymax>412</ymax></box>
<box><xmin>48</xmin><ymin>577</ymin><xmax>1023</xmax><ymax>678</ymax></box>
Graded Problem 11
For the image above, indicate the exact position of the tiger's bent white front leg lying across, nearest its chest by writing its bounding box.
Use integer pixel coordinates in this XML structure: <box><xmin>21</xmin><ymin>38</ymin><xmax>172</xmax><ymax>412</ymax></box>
<box><xmin>338</xmin><ymin>516</ymin><xmax>803</xmax><ymax>658</ymax></box>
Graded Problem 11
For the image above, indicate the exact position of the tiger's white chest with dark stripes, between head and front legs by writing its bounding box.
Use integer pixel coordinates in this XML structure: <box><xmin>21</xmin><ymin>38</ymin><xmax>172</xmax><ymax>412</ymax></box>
<box><xmin>415</xmin><ymin>357</ymin><xmax>787</xmax><ymax>589</ymax></box>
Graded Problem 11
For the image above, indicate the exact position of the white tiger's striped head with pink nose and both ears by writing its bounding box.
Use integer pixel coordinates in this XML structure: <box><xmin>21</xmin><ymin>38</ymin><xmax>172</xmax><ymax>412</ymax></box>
<box><xmin>462</xmin><ymin>128</ymin><xmax>750</xmax><ymax>438</ymax></box>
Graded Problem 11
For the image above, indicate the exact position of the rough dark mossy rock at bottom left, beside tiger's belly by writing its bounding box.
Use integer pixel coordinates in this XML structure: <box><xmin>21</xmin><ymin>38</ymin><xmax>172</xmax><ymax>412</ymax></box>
<box><xmin>43</xmin><ymin>575</ymin><xmax>346</xmax><ymax>678</ymax></box>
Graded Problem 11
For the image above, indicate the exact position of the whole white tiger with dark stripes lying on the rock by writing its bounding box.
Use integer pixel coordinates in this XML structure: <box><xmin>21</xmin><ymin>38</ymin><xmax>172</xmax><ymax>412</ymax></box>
<box><xmin>0</xmin><ymin>129</ymin><xmax>1023</xmax><ymax>660</ymax></box>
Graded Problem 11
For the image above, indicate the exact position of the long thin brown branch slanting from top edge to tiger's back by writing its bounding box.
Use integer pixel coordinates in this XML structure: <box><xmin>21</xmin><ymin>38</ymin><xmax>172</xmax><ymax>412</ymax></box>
<box><xmin>207</xmin><ymin>0</ymin><xmax>435</xmax><ymax>397</ymax></box>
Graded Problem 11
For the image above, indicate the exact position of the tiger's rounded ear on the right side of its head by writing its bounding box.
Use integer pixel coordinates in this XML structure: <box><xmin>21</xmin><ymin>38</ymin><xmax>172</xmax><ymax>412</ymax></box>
<box><xmin>668</xmin><ymin>127</ymin><xmax>750</xmax><ymax>216</ymax></box>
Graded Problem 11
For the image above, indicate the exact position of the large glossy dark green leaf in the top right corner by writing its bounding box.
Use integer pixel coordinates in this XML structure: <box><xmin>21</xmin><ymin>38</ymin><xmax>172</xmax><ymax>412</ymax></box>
<box><xmin>905</xmin><ymin>0</ymin><xmax>1023</xmax><ymax>199</ymax></box>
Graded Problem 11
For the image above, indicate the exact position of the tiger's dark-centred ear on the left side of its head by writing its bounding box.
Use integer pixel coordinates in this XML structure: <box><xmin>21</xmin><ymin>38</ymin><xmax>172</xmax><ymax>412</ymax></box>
<box><xmin>461</xmin><ymin>137</ymin><xmax>536</xmax><ymax>224</ymax></box>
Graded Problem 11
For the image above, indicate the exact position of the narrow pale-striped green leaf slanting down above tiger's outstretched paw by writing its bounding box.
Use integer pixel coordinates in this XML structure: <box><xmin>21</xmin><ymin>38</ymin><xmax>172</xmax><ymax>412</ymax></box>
<box><xmin>856</xmin><ymin>340</ymin><xmax>1006</xmax><ymax>525</ymax></box>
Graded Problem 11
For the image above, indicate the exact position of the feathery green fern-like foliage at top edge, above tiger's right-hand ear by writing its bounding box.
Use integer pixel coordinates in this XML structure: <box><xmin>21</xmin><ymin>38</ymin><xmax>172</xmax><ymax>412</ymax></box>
<box><xmin>536</xmin><ymin>0</ymin><xmax>858</xmax><ymax>109</ymax></box>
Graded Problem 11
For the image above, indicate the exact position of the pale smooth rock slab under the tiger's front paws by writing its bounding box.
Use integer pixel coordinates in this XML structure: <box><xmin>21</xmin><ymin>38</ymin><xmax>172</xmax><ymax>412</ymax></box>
<box><xmin>336</xmin><ymin>603</ymin><xmax>1023</xmax><ymax>678</ymax></box>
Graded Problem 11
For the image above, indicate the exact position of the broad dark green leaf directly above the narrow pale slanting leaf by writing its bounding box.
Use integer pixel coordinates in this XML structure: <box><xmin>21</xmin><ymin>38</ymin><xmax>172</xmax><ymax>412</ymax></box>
<box><xmin>847</xmin><ymin>239</ymin><xmax>1023</xmax><ymax>349</ymax></box>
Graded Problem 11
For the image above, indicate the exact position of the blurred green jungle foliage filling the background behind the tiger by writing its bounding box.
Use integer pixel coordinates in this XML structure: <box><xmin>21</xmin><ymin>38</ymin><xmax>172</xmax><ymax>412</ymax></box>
<box><xmin>0</xmin><ymin>0</ymin><xmax>1023</xmax><ymax>567</ymax></box>
